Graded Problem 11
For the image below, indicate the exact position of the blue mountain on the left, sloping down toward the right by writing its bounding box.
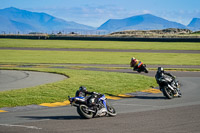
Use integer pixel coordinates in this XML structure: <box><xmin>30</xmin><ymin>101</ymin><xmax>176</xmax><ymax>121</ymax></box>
<box><xmin>0</xmin><ymin>7</ymin><xmax>95</xmax><ymax>33</ymax></box>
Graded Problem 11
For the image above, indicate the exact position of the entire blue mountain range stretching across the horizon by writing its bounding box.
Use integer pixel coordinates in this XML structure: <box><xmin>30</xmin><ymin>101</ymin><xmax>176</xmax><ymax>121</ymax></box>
<box><xmin>0</xmin><ymin>7</ymin><xmax>200</xmax><ymax>34</ymax></box>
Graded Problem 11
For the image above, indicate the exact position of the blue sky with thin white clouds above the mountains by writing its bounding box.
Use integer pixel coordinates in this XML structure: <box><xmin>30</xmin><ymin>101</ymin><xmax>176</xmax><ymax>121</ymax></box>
<box><xmin>0</xmin><ymin>0</ymin><xmax>200</xmax><ymax>27</ymax></box>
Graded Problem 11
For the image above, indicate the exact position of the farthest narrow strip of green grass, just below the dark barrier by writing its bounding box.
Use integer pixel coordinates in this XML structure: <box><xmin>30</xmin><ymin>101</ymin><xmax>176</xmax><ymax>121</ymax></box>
<box><xmin>0</xmin><ymin>39</ymin><xmax>200</xmax><ymax>50</ymax></box>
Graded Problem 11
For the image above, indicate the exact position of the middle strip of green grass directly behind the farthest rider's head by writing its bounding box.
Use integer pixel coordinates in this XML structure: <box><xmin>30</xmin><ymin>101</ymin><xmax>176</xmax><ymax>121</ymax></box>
<box><xmin>0</xmin><ymin>50</ymin><xmax>200</xmax><ymax>65</ymax></box>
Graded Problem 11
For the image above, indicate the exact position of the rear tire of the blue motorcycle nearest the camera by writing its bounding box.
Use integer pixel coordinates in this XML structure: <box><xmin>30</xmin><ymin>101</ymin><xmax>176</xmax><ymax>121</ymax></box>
<box><xmin>77</xmin><ymin>104</ymin><xmax>94</xmax><ymax>119</ymax></box>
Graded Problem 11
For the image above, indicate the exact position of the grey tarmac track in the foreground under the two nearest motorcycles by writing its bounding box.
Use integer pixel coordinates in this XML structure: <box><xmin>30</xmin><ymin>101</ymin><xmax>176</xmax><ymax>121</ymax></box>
<box><xmin>0</xmin><ymin>71</ymin><xmax>200</xmax><ymax>133</ymax></box>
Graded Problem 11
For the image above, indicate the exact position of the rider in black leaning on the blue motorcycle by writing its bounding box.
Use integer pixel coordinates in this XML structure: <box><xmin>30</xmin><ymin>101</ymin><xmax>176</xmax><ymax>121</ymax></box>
<box><xmin>75</xmin><ymin>86</ymin><xmax>101</xmax><ymax>107</ymax></box>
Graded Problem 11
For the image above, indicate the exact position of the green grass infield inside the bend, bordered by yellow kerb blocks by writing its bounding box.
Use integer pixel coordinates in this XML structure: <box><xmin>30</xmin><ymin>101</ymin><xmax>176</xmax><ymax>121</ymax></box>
<box><xmin>0</xmin><ymin>68</ymin><xmax>156</xmax><ymax>108</ymax></box>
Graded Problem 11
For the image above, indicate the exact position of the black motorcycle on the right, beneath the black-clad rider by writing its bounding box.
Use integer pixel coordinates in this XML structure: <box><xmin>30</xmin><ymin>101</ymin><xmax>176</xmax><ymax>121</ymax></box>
<box><xmin>156</xmin><ymin>75</ymin><xmax>181</xmax><ymax>99</ymax></box>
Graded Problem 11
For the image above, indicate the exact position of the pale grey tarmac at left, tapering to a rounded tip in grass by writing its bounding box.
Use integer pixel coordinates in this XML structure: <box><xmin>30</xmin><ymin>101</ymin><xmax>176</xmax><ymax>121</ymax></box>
<box><xmin>0</xmin><ymin>70</ymin><xmax>67</xmax><ymax>91</ymax></box>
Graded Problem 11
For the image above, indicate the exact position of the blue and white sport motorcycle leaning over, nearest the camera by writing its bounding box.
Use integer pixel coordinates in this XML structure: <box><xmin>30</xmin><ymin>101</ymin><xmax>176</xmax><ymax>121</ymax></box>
<box><xmin>68</xmin><ymin>94</ymin><xmax>117</xmax><ymax>119</ymax></box>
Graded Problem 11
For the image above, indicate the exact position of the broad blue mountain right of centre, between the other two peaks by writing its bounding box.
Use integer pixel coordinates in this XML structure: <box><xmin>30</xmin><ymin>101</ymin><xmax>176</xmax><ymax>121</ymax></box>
<box><xmin>98</xmin><ymin>14</ymin><xmax>187</xmax><ymax>31</ymax></box>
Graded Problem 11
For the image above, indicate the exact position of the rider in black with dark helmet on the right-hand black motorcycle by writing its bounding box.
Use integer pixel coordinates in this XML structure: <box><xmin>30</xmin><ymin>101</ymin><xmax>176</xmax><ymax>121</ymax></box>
<box><xmin>155</xmin><ymin>67</ymin><xmax>181</xmax><ymax>96</ymax></box>
